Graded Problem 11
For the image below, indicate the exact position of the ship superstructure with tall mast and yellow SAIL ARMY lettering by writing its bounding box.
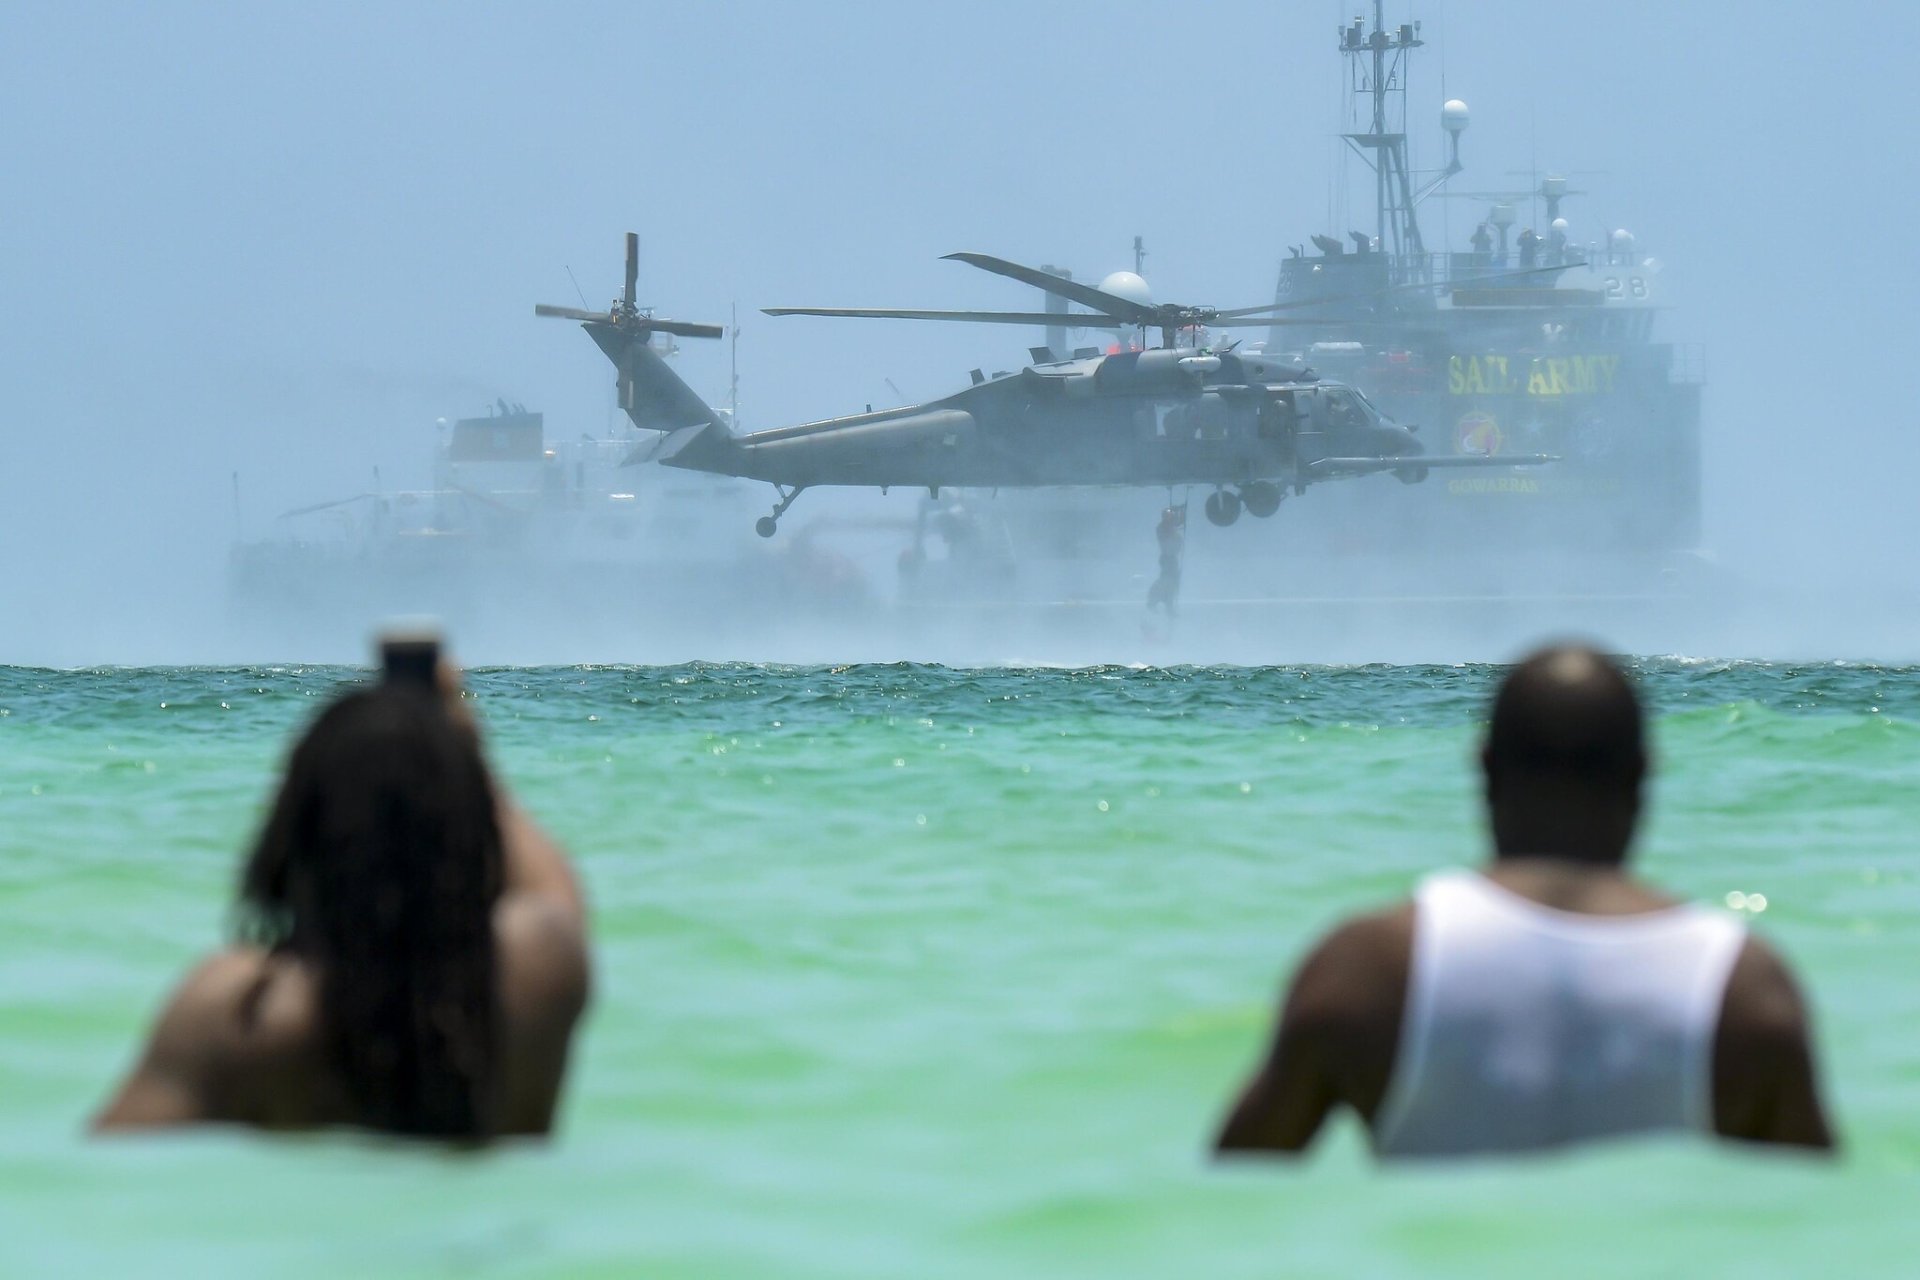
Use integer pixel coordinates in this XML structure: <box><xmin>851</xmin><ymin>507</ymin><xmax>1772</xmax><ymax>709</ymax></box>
<box><xmin>1267</xmin><ymin>2</ymin><xmax>1701</xmax><ymax>555</ymax></box>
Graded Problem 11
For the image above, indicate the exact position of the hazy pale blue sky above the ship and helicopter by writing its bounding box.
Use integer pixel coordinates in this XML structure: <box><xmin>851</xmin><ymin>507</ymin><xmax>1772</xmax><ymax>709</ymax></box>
<box><xmin>0</xmin><ymin>0</ymin><xmax>1920</xmax><ymax>660</ymax></box>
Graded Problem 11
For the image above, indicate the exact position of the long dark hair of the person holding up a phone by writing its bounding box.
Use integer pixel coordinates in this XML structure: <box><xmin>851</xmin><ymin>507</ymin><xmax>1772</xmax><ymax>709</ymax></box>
<box><xmin>238</xmin><ymin>685</ymin><xmax>501</xmax><ymax>1138</ymax></box>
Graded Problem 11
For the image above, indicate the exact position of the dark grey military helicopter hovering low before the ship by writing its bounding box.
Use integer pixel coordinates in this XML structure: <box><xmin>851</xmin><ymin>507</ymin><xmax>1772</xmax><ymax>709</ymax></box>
<box><xmin>534</xmin><ymin>232</ymin><xmax>1553</xmax><ymax>537</ymax></box>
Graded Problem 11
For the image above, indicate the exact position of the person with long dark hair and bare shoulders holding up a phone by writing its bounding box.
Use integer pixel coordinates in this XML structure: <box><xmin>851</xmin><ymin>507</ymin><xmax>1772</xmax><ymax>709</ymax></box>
<box><xmin>96</xmin><ymin>670</ymin><xmax>588</xmax><ymax>1142</ymax></box>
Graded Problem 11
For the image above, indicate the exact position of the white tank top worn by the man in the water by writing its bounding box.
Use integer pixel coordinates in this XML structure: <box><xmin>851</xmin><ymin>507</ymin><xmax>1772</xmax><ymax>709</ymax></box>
<box><xmin>1373</xmin><ymin>871</ymin><xmax>1745</xmax><ymax>1155</ymax></box>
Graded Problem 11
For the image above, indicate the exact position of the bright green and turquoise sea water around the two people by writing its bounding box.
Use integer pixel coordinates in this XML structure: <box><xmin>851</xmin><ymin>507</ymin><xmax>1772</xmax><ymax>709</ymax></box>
<box><xmin>0</xmin><ymin>660</ymin><xmax>1920</xmax><ymax>1278</ymax></box>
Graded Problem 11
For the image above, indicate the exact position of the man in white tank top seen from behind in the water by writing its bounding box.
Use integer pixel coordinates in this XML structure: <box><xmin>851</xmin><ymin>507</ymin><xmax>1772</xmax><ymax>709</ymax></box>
<box><xmin>1217</xmin><ymin>649</ymin><xmax>1834</xmax><ymax>1157</ymax></box>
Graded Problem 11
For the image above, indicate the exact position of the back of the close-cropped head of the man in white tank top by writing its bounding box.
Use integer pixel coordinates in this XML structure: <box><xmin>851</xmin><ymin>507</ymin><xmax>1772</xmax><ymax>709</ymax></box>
<box><xmin>1482</xmin><ymin>647</ymin><xmax>1647</xmax><ymax>858</ymax></box>
